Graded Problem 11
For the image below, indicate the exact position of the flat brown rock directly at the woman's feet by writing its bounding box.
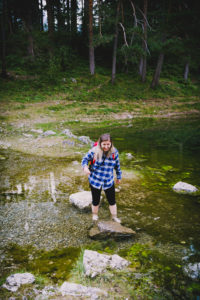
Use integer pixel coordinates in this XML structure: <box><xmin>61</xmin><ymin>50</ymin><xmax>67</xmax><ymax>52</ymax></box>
<box><xmin>89</xmin><ymin>221</ymin><xmax>136</xmax><ymax>239</ymax></box>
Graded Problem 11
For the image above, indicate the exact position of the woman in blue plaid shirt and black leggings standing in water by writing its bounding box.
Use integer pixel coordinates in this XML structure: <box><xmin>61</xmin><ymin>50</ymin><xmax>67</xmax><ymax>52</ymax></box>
<box><xmin>82</xmin><ymin>133</ymin><xmax>121</xmax><ymax>223</ymax></box>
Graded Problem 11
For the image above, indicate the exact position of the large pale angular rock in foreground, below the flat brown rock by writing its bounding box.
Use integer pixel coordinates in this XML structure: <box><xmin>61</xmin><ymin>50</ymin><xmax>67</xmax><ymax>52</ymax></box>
<box><xmin>83</xmin><ymin>250</ymin><xmax>130</xmax><ymax>278</ymax></box>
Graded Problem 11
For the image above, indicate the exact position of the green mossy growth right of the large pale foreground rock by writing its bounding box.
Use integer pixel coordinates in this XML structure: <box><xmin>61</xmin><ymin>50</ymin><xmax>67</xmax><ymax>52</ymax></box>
<box><xmin>120</xmin><ymin>243</ymin><xmax>198</xmax><ymax>299</ymax></box>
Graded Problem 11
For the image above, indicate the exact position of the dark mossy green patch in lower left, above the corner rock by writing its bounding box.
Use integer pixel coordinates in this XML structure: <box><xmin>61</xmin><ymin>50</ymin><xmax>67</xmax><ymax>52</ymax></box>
<box><xmin>2</xmin><ymin>245</ymin><xmax>81</xmax><ymax>285</ymax></box>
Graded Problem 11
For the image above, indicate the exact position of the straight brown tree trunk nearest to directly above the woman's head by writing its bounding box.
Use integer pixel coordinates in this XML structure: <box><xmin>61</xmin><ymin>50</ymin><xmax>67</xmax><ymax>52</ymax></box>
<box><xmin>89</xmin><ymin>0</ymin><xmax>95</xmax><ymax>75</ymax></box>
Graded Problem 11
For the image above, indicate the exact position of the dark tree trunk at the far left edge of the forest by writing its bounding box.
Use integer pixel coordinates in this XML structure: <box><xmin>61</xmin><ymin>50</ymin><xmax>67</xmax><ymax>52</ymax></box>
<box><xmin>0</xmin><ymin>0</ymin><xmax>7</xmax><ymax>78</ymax></box>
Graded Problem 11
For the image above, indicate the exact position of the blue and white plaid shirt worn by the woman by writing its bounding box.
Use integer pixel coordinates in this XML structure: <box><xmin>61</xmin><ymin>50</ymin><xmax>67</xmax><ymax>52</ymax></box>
<box><xmin>81</xmin><ymin>148</ymin><xmax>122</xmax><ymax>190</ymax></box>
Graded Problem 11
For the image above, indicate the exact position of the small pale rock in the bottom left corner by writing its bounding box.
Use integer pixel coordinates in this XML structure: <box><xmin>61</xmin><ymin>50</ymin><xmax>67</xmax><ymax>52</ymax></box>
<box><xmin>3</xmin><ymin>273</ymin><xmax>35</xmax><ymax>292</ymax></box>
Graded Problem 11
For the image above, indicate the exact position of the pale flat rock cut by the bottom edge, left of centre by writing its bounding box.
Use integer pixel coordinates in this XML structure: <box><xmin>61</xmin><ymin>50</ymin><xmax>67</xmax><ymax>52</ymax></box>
<box><xmin>60</xmin><ymin>281</ymin><xmax>107</xmax><ymax>299</ymax></box>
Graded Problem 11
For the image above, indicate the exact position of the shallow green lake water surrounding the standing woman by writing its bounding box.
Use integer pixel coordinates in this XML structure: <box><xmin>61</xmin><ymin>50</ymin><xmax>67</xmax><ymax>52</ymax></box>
<box><xmin>0</xmin><ymin>119</ymin><xmax>200</xmax><ymax>296</ymax></box>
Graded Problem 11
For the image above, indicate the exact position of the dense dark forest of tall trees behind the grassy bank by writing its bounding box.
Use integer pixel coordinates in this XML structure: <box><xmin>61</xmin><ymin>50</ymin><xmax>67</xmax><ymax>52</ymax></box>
<box><xmin>0</xmin><ymin>0</ymin><xmax>200</xmax><ymax>88</ymax></box>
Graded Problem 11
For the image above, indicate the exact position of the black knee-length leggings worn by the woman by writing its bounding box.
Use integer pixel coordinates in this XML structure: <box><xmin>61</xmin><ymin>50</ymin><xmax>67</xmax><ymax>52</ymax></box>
<box><xmin>90</xmin><ymin>184</ymin><xmax>116</xmax><ymax>206</ymax></box>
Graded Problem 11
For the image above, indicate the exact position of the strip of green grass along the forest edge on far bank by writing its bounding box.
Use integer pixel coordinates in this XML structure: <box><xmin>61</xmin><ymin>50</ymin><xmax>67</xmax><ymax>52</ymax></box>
<box><xmin>0</xmin><ymin>63</ymin><xmax>200</xmax><ymax>105</ymax></box>
